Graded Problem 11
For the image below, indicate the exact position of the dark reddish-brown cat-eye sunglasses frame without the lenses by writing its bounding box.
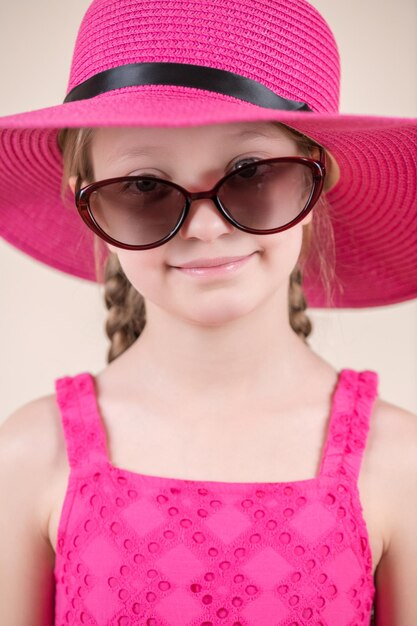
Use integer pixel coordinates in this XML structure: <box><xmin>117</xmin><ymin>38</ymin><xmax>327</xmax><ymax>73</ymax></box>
<box><xmin>75</xmin><ymin>146</ymin><xmax>326</xmax><ymax>250</ymax></box>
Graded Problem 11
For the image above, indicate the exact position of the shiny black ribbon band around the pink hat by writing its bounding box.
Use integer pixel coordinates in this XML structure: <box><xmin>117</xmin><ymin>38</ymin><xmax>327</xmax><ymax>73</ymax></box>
<box><xmin>64</xmin><ymin>63</ymin><xmax>312</xmax><ymax>112</ymax></box>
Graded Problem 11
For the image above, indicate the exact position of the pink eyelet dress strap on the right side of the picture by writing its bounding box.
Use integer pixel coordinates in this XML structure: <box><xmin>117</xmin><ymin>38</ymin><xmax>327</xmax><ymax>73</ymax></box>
<box><xmin>320</xmin><ymin>369</ymin><xmax>379</xmax><ymax>482</ymax></box>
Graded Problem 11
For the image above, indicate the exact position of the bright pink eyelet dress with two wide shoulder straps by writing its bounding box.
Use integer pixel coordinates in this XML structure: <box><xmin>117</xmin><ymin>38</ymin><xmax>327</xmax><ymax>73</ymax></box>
<box><xmin>55</xmin><ymin>369</ymin><xmax>378</xmax><ymax>626</ymax></box>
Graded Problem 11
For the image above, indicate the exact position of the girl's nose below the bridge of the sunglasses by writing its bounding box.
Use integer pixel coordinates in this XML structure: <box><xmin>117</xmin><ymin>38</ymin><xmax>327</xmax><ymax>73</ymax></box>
<box><xmin>178</xmin><ymin>198</ymin><xmax>235</xmax><ymax>242</ymax></box>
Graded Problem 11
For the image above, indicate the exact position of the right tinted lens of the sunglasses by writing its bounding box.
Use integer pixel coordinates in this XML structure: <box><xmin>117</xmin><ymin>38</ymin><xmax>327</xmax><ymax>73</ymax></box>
<box><xmin>219</xmin><ymin>161</ymin><xmax>314</xmax><ymax>230</ymax></box>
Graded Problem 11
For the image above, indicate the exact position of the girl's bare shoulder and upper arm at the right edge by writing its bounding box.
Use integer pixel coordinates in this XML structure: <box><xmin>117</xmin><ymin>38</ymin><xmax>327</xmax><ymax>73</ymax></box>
<box><xmin>365</xmin><ymin>400</ymin><xmax>417</xmax><ymax>626</ymax></box>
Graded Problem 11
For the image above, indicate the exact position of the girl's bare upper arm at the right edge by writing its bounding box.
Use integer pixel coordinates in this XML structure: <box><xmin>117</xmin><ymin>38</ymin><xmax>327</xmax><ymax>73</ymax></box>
<box><xmin>375</xmin><ymin>405</ymin><xmax>417</xmax><ymax>626</ymax></box>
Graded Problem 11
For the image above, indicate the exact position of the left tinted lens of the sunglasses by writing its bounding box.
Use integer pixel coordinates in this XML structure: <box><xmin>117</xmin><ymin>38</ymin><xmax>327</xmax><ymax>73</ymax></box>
<box><xmin>89</xmin><ymin>178</ymin><xmax>185</xmax><ymax>245</ymax></box>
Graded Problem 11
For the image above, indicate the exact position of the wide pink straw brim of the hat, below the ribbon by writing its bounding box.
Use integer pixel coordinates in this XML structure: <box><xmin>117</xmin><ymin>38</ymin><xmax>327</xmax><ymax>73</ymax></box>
<box><xmin>0</xmin><ymin>85</ymin><xmax>417</xmax><ymax>308</ymax></box>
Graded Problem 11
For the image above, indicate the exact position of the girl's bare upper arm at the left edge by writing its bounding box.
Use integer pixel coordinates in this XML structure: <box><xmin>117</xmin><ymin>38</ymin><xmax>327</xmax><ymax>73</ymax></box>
<box><xmin>0</xmin><ymin>398</ymin><xmax>55</xmax><ymax>626</ymax></box>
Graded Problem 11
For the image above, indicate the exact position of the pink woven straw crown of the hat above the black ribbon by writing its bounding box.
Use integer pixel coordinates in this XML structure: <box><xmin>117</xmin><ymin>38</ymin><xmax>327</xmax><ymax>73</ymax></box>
<box><xmin>67</xmin><ymin>0</ymin><xmax>340</xmax><ymax>113</ymax></box>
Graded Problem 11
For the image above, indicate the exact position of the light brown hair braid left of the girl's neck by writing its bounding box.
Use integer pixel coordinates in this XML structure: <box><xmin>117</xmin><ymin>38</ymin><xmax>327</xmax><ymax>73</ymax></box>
<box><xmin>104</xmin><ymin>253</ymin><xmax>146</xmax><ymax>363</ymax></box>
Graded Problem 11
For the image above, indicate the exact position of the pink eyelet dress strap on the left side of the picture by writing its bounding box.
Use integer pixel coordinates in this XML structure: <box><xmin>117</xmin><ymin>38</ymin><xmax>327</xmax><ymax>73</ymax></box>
<box><xmin>55</xmin><ymin>372</ymin><xmax>108</xmax><ymax>469</ymax></box>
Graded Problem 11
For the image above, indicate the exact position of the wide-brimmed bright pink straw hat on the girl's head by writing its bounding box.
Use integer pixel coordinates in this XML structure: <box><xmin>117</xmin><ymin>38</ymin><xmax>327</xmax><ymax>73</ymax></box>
<box><xmin>0</xmin><ymin>0</ymin><xmax>417</xmax><ymax>307</ymax></box>
